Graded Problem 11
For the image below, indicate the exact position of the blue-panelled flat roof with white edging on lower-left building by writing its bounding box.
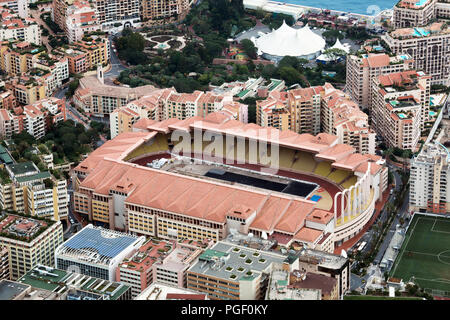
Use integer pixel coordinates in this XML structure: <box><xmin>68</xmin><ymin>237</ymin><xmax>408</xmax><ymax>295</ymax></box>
<box><xmin>56</xmin><ymin>225</ymin><xmax>138</xmax><ymax>265</ymax></box>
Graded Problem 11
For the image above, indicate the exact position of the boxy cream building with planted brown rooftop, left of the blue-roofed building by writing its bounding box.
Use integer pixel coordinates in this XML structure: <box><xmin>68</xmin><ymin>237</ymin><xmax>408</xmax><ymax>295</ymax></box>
<box><xmin>0</xmin><ymin>213</ymin><xmax>63</xmax><ymax>280</ymax></box>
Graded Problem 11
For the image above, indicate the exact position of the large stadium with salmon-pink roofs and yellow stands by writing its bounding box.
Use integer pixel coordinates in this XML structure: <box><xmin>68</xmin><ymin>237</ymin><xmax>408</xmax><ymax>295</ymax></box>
<box><xmin>72</xmin><ymin>113</ymin><xmax>387</xmax><ymax>252</ymax></box>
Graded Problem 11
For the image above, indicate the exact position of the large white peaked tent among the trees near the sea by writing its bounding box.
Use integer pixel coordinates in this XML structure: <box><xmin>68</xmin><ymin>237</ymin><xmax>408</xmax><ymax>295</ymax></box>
<box><xmin>254</xmin><ymin>21</ymin><xmax>325</xmax><ymax>61</ymax></box>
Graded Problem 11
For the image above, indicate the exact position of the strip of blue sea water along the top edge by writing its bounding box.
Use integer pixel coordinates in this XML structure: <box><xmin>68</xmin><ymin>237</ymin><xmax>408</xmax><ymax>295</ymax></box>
<box><xmin>282</xmin><ymin>0</ymin><xmax>397</xmax><ymax>15</ymax></box>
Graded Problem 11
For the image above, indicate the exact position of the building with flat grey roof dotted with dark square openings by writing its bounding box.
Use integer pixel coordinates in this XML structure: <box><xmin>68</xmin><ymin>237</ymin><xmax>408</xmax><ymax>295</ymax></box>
<box><xmin>187</xmin><ymin>241</ymin><xmax>298</xmax><ymax>300</ymax></box>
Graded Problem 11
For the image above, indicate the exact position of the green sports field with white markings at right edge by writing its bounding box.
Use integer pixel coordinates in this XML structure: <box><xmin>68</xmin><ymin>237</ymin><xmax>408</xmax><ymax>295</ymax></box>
<box><xmin>391</xmin><ymin>214</ymin><xmax>450</xmax><ymax>295</ymax></box>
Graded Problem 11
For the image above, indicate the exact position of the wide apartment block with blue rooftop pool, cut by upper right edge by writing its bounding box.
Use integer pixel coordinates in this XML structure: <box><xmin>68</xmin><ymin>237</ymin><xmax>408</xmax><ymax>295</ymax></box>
<box><xmin>382</xmin><ymin>22</ymin><xmax>450</xmax><ymax>85</ymax></box>
